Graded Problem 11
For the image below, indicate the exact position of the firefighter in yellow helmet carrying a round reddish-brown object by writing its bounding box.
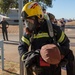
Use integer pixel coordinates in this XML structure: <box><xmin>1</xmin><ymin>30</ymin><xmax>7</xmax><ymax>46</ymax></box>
<box><xmin>18</xmin><ymin>2</ymin><xmax>72</xmax><ymax>75</ymax></box>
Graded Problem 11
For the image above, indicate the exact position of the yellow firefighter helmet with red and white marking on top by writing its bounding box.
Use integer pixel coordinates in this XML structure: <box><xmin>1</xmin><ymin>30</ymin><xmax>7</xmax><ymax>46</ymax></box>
<box><xmin>21</xmin><ymin>2</ymin><xmax>43</xmax><ymax>19</ymax></box>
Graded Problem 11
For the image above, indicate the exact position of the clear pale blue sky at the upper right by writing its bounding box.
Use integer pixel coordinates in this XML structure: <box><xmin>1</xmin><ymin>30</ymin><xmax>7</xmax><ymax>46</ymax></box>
<box><xmin>47</xmin><ymin>0</ymin><xmax>75</xmax><ymax>19</ymax></box>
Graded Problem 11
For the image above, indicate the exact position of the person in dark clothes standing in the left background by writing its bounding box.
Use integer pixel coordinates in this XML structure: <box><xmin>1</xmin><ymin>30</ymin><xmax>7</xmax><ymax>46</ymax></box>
<box><xmin>0</xmin><ymin>18</ymin><xmax>9</xmax><ymax>41</ymax></box>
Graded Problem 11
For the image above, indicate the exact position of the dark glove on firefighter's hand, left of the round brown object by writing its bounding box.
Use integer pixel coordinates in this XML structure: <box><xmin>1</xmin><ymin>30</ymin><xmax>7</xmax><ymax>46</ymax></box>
<box><xmin>22</xmin><ymin>50</ymin><xmax>39</xmax><ymax>68</ymax></box>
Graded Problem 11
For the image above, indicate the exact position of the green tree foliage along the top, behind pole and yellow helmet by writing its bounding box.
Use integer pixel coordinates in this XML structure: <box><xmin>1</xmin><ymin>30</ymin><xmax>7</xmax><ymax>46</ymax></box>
<box><xmin>0</xmin><ymin>0</ymin><xmax>52</xmax><ymax>14</ymax></box>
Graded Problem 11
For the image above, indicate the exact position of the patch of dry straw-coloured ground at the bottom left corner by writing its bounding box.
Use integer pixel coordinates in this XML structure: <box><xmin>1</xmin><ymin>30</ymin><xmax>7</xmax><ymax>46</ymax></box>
<box><xmin>0</xmin><ymin>61</ymin><xmax>20</xmax><ymax>75</ymax></box>
